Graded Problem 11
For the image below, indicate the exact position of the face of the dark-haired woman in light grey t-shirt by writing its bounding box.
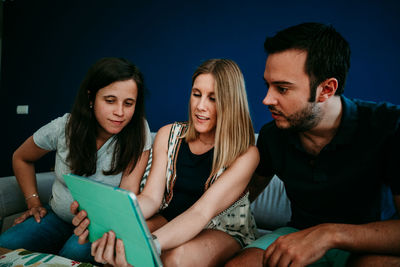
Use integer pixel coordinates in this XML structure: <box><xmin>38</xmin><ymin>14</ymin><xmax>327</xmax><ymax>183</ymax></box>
<box><xmin>93</xmin><ymin>80</ymin><xmax>138</xmax><ymax>140</ymax></box>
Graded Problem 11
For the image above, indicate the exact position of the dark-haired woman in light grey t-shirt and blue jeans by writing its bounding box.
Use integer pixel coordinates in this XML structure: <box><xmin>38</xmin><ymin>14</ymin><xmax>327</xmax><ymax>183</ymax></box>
<box><xmin>0</xmin><ymin>58</ymin><xmax>151</xmax><ymax>261</ymax></box>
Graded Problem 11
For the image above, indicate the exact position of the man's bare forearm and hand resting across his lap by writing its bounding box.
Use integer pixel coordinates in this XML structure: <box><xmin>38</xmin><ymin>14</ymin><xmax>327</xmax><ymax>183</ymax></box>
<box><xmin>264</xmin><ymin>196</ymin><xmax>400</xmax><ymax>266</ymax></box>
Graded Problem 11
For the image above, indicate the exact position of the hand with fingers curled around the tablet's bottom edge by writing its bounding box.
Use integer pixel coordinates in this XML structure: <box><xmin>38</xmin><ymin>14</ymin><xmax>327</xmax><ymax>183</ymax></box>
<box><xmin>92</xmin><ymin>231</ymin><xmax>132</xmax><ymax>267</ymax></box>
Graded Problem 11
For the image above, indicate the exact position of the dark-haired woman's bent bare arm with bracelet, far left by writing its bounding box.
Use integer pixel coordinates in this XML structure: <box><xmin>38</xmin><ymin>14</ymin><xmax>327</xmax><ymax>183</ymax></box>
<box><xmin>12</xmin><ymin>136</ymin><xmax>49</xmax><ymax>223</ymax></box>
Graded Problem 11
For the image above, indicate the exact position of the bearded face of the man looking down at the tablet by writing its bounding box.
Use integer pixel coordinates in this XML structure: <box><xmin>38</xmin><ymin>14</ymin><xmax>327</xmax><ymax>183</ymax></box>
<box><xmin>263</xmin><ymin>49</ymin><xmax>321</xmax><ymax>132</ymax></box>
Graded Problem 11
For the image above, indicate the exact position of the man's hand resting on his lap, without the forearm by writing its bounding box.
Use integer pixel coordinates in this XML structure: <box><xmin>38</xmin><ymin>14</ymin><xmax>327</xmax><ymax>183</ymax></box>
<box><xmin>263</xmin><ymin>224</ymin><xmax>333</xmax><ymax>267</ymax></box>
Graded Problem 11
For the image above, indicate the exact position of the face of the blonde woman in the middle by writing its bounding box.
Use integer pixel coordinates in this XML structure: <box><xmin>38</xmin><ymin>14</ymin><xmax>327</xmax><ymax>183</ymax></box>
<box><xmin>190</xmin><ymin>74</ymin><xmax>217</xmax><ymax>135</ymax></box>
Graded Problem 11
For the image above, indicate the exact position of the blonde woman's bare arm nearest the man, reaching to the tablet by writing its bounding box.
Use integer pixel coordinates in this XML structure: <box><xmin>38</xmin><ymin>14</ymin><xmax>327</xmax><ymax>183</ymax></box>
<box><xmin>154</xmin><ymin>146</ymin><xmax>259</xmax><ymax>250</ymax></box>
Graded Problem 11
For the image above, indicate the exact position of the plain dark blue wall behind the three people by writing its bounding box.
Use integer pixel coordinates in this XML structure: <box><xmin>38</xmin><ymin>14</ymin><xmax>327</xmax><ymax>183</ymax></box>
<box><xmin>0</xmin><ymin>0</ymin><xmax>400</xmax><ymax>176</ymax></box>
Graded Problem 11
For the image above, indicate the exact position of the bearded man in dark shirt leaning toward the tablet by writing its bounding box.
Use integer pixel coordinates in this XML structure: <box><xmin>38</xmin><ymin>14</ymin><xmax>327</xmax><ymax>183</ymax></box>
<box><xmin>228</xmin><ymin>23</ymin><xmax>400</xmax><ymax>266</ymax></box>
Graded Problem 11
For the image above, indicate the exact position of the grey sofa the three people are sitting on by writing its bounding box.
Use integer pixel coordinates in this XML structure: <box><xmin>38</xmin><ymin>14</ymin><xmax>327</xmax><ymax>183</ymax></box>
<box><xmin>0</xmin><ymin>172</ymin><xmax>291</xmax><ymax>237</ymax></box>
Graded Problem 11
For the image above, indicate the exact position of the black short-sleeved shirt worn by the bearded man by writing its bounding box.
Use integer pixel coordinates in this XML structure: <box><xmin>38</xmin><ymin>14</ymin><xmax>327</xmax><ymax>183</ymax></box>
<box><xmin>256</xmin><ymin>96</ymin><xmax>400</xmax><ymax>229</ymax></box>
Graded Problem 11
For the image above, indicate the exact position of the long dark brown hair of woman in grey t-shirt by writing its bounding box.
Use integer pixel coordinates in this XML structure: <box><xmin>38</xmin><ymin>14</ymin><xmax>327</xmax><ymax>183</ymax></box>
<box><xmin>65</xmin><ymin>58</ymin><xmax>146</xmax><ymax>176</ymax></box>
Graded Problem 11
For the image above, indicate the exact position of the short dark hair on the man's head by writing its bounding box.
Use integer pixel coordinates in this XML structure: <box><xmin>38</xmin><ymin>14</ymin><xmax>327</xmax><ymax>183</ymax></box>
<box><xmin>264</xmin><ymin>23</ymin><xmax>351</xmax><ymax>101</ymax></box>
